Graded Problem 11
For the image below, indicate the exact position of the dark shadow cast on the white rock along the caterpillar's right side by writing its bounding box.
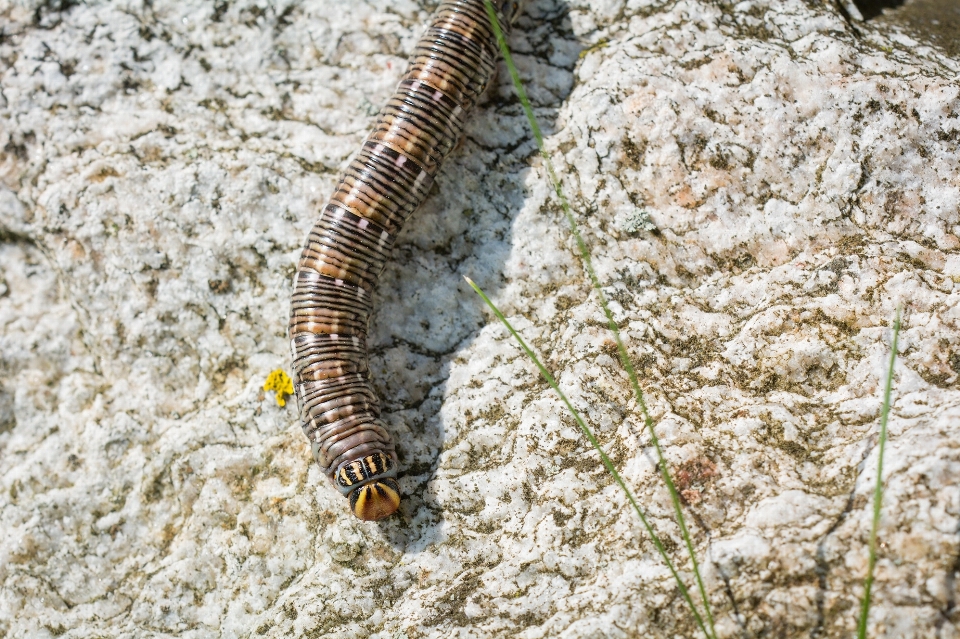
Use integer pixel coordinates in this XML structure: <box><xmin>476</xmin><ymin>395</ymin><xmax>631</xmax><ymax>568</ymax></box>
<box><xmin>370</xmin><ymin>0</ymin><xmax>585</xmax><ymax>552</ymax></box>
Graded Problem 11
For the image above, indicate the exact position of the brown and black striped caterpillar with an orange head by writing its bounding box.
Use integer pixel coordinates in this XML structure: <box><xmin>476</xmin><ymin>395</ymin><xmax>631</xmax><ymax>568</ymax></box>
<box><xmin>288</xmin><ymin>0</ymin><xmax>519</xmax><ymax>521</ymax></box>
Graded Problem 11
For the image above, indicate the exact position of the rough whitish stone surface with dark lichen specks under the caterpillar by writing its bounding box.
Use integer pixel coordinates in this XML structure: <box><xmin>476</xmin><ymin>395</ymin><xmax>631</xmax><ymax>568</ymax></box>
<box><xmin>0</xmin><ymin>0</ymin><xmax>960</xmax><ymax>639</ymax></box>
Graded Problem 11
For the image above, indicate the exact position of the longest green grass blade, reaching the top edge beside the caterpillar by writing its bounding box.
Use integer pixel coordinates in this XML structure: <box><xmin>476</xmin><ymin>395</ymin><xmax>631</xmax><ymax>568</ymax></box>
<box><xmin>484</xmin><ymin>0</ymin><xmax>716</xmax><ymax>637</ymax></box>
